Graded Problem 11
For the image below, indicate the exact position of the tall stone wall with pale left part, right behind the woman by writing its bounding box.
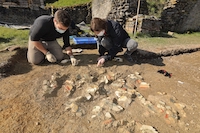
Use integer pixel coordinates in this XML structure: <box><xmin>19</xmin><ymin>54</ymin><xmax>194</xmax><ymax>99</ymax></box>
<box><xmin>92</xmin><ymin>0</ymin><xmax>148</xmax><ymax>25</ymax></box>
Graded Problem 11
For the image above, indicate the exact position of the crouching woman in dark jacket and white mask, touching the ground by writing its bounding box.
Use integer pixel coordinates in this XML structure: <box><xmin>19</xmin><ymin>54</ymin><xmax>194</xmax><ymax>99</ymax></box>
<box><xmin>90</xmin><ymin>18</ymin><xmax>138</xmax><ymax>66</ymax></box>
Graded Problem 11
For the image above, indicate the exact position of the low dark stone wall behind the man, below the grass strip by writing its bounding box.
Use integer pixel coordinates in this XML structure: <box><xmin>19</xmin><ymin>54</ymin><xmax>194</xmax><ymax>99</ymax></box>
<box><xmin>0</xmin><ymin>5</ymin><xmax>91</xmax><ymax>25</ymax></box>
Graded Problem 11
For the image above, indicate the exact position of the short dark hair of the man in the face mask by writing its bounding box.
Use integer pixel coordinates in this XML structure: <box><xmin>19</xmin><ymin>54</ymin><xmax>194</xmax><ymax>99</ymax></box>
<box><xmin>54</xmin><ymin>9</ymin><xmax>71</xmax><ymax>27</ymax></box>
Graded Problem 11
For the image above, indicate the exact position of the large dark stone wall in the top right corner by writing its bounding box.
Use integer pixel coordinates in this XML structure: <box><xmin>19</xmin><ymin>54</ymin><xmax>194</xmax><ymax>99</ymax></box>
<box><xmin>161</xmin><ymin>0</ymin><xmax>200</xmax><ymax>33</ymax></box>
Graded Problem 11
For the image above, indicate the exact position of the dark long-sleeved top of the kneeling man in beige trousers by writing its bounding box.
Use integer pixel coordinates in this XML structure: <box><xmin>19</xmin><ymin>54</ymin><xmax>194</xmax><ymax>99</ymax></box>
<box><xmin>29</xmin><ymin>15</ymin><xmax>70</xmax><ymax>48</ymax></box>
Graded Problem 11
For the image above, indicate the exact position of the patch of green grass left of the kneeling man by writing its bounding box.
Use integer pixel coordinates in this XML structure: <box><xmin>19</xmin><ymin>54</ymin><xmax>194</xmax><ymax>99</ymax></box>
<box><xmin>0</xmin><ymin>27</ymin><xmax>29</xmax><ymax>49</ymax></box>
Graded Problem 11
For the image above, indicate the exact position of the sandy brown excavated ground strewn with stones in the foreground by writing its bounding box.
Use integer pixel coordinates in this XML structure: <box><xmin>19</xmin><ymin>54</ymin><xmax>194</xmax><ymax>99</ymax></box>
<box><xmin>0</xmin><ymin>46</ymin><xmax>200</xmax><ymax>133</ymax></box>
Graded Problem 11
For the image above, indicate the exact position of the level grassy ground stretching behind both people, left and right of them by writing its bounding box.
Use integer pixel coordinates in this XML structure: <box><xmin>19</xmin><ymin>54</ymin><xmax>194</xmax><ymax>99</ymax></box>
<box><xmin>0</xmin><ymin>27</ymin><xmax>200</xmax><ymax>49</ymax></box>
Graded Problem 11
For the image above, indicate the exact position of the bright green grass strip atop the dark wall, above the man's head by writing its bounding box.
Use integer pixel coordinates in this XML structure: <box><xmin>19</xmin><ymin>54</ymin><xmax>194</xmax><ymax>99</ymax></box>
<box><xmin>46</xmin><ymin>0</ymin><xmax>92</xmax><ymax>8</ymax></box>
